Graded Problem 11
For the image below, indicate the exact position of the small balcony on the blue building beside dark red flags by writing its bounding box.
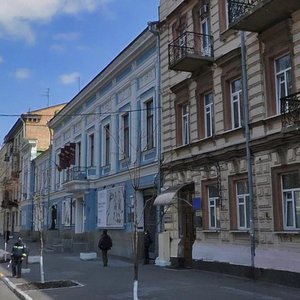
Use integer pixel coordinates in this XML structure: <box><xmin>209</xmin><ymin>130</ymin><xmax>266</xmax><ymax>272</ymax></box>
<box><xmin>63</xmin><ymin>166</ymin><xmax>96</xmax><ymax>193</ymax></box>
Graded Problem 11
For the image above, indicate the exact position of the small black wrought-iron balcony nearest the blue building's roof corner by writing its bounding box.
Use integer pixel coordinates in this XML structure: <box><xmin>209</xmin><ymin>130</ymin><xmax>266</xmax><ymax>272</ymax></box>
<box><xmin>169</xmin><ymin>31</ymin><xmax>214</xmax><ymax>72</ymax></box>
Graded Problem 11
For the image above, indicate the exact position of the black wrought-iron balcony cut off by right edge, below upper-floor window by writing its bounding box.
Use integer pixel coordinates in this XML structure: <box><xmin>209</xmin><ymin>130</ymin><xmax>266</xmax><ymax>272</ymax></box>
<box><xmin>280</xmin><ymin>92</ymin><xmax>300</xmax><ymax>128</ymax></box>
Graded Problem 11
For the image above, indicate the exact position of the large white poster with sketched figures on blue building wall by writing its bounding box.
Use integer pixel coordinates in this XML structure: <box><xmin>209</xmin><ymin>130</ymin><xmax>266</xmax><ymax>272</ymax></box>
<box><xmin>97</xmin><ymin>186</ymin><xmax>124</xmax><ymax>228</ymax></box>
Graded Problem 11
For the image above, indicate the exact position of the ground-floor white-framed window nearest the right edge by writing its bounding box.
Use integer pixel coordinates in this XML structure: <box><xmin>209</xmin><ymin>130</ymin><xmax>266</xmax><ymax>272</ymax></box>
<box><xmin>282</xmin><ymin>172</ymin><xmax>300</xmax><ymax>230</ymax></box>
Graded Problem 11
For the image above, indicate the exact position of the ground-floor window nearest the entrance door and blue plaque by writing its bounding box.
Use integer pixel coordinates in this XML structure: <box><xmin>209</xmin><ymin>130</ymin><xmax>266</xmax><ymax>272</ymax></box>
<box><xmin>208</xmin><ymin>186</ymin><xmax>220</xmax><ymax>229</ymax></box>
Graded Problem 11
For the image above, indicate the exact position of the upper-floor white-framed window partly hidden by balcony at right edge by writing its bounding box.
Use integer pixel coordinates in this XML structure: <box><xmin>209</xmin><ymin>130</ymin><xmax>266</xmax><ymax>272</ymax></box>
<box><xmin>275</xmin><ymin>55</ymin><xmax>292</xmax><ymax>114</ymax></box>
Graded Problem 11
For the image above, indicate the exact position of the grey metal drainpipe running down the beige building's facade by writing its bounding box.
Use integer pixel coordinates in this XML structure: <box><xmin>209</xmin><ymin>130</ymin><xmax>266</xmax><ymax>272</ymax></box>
<box><xmin>240</xmin><ymin>31</ymin><xmax>255</xmax><ymax>268</ymax></box>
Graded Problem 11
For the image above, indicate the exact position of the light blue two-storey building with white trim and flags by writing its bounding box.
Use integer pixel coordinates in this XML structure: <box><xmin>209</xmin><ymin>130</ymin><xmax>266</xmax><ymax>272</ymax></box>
<box><xmin>47</xmin><ymin>29</ymin><xmax>160</xmax><ymax>257</ymax></box>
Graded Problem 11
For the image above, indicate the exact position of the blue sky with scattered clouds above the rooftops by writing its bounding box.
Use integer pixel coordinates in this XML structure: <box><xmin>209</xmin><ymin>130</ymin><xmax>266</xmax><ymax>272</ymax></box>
<box><xmin>0</xmin><ymin>0</ymin><xmax>159</xmax><ymax>144</ymax></box>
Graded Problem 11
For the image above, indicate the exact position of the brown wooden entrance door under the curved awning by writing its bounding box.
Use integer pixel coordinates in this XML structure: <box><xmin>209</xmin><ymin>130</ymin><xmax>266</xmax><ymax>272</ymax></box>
<box><xmin>178</xmin><ymin>191</ymin><xmax>195</xmax><ymax>267</ymax></box>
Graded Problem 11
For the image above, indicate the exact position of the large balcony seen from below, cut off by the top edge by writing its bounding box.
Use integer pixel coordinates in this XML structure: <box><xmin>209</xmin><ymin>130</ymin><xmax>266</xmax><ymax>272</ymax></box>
<box><xmin>228</xmin><ymin>0</ymin><xmax>300</xmax><ymax>32</ymax></box>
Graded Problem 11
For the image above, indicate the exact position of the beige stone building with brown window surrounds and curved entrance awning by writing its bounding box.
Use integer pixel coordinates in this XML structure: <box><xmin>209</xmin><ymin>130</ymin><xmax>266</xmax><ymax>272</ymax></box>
<box><xmin>154</xmin><ymin>0</ymin><xmax>300</xmax><ymax>272</ymax></box>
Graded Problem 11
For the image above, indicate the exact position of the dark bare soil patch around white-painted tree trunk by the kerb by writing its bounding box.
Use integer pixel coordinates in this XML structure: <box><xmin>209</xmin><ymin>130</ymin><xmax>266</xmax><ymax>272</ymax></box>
<box><xmin>18</xmin><ymin>280</ymin><xmax>82</xmax><ymax>291</ymax></box>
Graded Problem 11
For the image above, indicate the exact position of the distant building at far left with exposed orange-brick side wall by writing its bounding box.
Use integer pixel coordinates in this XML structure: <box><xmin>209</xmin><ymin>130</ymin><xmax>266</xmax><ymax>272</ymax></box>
<box><xmin>0</xmin><ymin>105</ymin><xmax>63</xmax><ymax>239</ymax></box>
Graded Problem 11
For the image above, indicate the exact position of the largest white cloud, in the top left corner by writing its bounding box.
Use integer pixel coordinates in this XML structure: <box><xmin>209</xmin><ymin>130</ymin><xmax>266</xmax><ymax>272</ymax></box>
<box><xmin>0</xmin><ymin>0</ymin><xmax>114</xmax><ymax>43</ymax></box>
